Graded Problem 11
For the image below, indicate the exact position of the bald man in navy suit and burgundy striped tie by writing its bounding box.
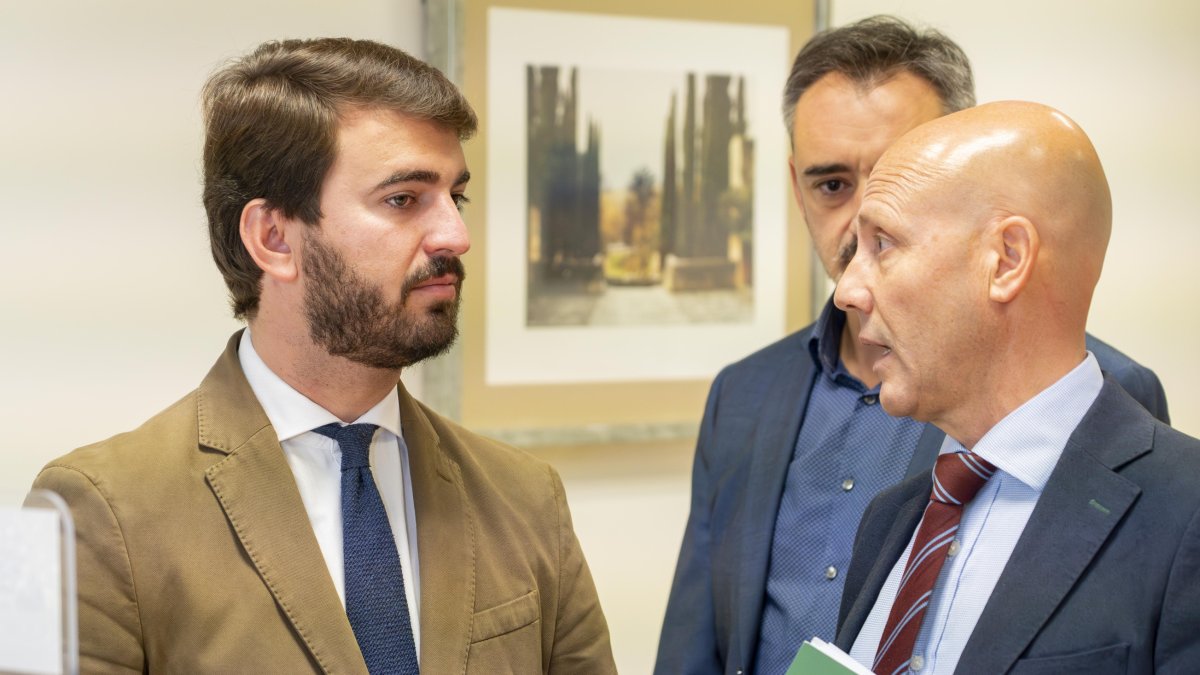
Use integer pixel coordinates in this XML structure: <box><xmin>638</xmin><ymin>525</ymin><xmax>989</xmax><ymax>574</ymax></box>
<box><xmin>834</xmin><ymin>102</ymin><xmax>1200</xmax><ymax>675</ymax></box>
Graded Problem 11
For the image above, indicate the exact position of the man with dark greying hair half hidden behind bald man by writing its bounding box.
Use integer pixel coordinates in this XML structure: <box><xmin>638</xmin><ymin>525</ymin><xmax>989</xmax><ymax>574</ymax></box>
<box><xmin>656</xmin><ymin>17</ymin><xmax>1168</xmax><ymax>675</ymax></box>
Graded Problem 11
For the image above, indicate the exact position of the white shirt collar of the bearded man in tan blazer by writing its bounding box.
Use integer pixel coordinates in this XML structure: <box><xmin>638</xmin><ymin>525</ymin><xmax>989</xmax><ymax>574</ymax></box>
<box><xmin>238</xmin><ymin>328</ymin><xmax>402</xmax><ymax>443</ymax></box>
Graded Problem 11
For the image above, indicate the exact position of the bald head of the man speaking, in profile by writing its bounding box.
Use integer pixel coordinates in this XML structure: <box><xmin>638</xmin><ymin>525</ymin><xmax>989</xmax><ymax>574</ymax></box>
<box><xmin>834</xmin><ymin>102</ymin><xmax>1112</xmax><ymax>443</ymax></box>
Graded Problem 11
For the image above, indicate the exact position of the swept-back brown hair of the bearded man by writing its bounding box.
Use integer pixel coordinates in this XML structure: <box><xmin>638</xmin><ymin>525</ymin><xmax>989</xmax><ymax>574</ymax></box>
<box><xmin>203</xmin><ymin>37</ymin><xmax>476</xmax><ymax>318</ymax></box>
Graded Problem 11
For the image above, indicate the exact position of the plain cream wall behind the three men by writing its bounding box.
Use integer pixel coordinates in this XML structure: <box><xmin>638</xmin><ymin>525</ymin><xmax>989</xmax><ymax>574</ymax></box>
<box><xmin>0</xmin><ymin>0</ymin><xmax>1200</xmax><ymax>674</ymax></box>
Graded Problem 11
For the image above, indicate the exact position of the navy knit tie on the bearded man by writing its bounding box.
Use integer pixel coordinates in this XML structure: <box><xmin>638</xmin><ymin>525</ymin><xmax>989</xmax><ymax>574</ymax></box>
<box><xmin>313</xmin><ymin>424</ymin><xmax>419</xmax><ymax>675</ymax></box>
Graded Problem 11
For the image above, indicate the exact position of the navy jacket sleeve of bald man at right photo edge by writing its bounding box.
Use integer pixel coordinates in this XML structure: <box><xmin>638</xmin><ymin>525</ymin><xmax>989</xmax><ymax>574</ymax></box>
<box><xmin>1154</xmin><ymin>502</ymin><xmax>1200</xmax><ymax>675</ymax></box>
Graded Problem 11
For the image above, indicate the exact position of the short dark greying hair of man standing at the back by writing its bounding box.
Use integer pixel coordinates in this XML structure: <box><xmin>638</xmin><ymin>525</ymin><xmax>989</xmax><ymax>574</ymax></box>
<box><xmin>784</xmin><ymin>16</ymin><xmax>974</xmax><ymax>137</ymax></box>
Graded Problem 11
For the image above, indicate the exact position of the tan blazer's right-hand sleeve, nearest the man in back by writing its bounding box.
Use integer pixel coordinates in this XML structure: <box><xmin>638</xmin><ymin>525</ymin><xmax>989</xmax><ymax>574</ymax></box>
<box><xmin>547</xmin><ymin>470</ymin><xmax>617</xmax><ymax>675</ymax></box>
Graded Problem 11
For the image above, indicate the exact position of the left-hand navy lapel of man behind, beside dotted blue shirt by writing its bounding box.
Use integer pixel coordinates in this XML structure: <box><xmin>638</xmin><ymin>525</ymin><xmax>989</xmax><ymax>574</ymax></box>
<box><xmin>731</xmin><ymin>334</ymin><xmax>815</xmax><ymax>663</ymax></box>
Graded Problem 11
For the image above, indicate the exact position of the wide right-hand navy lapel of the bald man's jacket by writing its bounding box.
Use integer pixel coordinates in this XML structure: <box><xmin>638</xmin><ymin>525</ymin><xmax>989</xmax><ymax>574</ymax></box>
<box><xmin>956</xmin><ymin>380</ymin><xmax>1154</xmax><ymax>673</ymax></box>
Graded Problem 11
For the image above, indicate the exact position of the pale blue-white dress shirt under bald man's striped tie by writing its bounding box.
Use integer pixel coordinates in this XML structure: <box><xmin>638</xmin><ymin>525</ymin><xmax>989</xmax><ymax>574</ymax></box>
<box><xmin>850</xmin><ymin>352</ymin><xmax>1104</xmax><ymax>675</ymax></box>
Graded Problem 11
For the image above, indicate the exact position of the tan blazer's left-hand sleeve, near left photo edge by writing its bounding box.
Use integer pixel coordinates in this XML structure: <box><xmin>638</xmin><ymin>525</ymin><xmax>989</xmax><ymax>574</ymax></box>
<box><xmin>34</xmin><ymin>466</ymin><xmax>144</xmax><ymax>673</ymax></box>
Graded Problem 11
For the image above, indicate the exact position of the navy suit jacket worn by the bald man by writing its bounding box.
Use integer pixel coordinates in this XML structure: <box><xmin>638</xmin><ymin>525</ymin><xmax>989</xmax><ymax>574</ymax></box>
<box><xmin>838</xmin><ymin>378</ymin><xmax>1200</xmax><ymax>674</ymax></box>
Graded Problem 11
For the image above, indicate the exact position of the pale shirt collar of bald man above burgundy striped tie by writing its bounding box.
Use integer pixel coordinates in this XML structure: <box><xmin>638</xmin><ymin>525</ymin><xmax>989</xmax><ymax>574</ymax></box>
<box><xmin>941</xmin><ymin>352</ymin><xmax>1104</xmax><ymax>492</ymax></box>
